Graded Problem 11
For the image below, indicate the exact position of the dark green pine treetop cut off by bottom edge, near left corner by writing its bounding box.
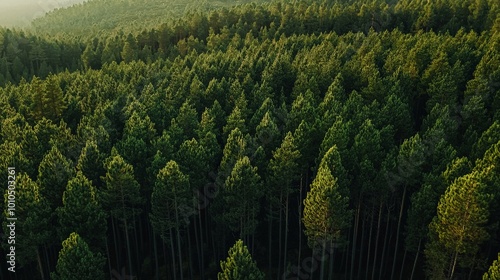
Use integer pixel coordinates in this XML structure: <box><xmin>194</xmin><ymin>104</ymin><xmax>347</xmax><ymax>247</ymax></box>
<box><xmin>50</xmin><ymin>232</ymin><xmax>106</xmax><ymax>280</ymax></box>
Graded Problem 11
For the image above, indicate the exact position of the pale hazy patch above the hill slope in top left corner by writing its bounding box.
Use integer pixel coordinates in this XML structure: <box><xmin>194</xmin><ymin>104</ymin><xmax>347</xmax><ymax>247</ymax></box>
<box><xmin>0</xmin><ymin>0</ymin><xmax>87</xmax><ymax>27</ymax></box>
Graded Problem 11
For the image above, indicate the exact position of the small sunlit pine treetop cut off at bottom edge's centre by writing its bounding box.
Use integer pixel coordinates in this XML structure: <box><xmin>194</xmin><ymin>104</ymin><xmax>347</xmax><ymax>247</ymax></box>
<box><xmin>217</xmin><ymin>240</ymin><xmax>264</xmax><ymax>280</ymax></box>
